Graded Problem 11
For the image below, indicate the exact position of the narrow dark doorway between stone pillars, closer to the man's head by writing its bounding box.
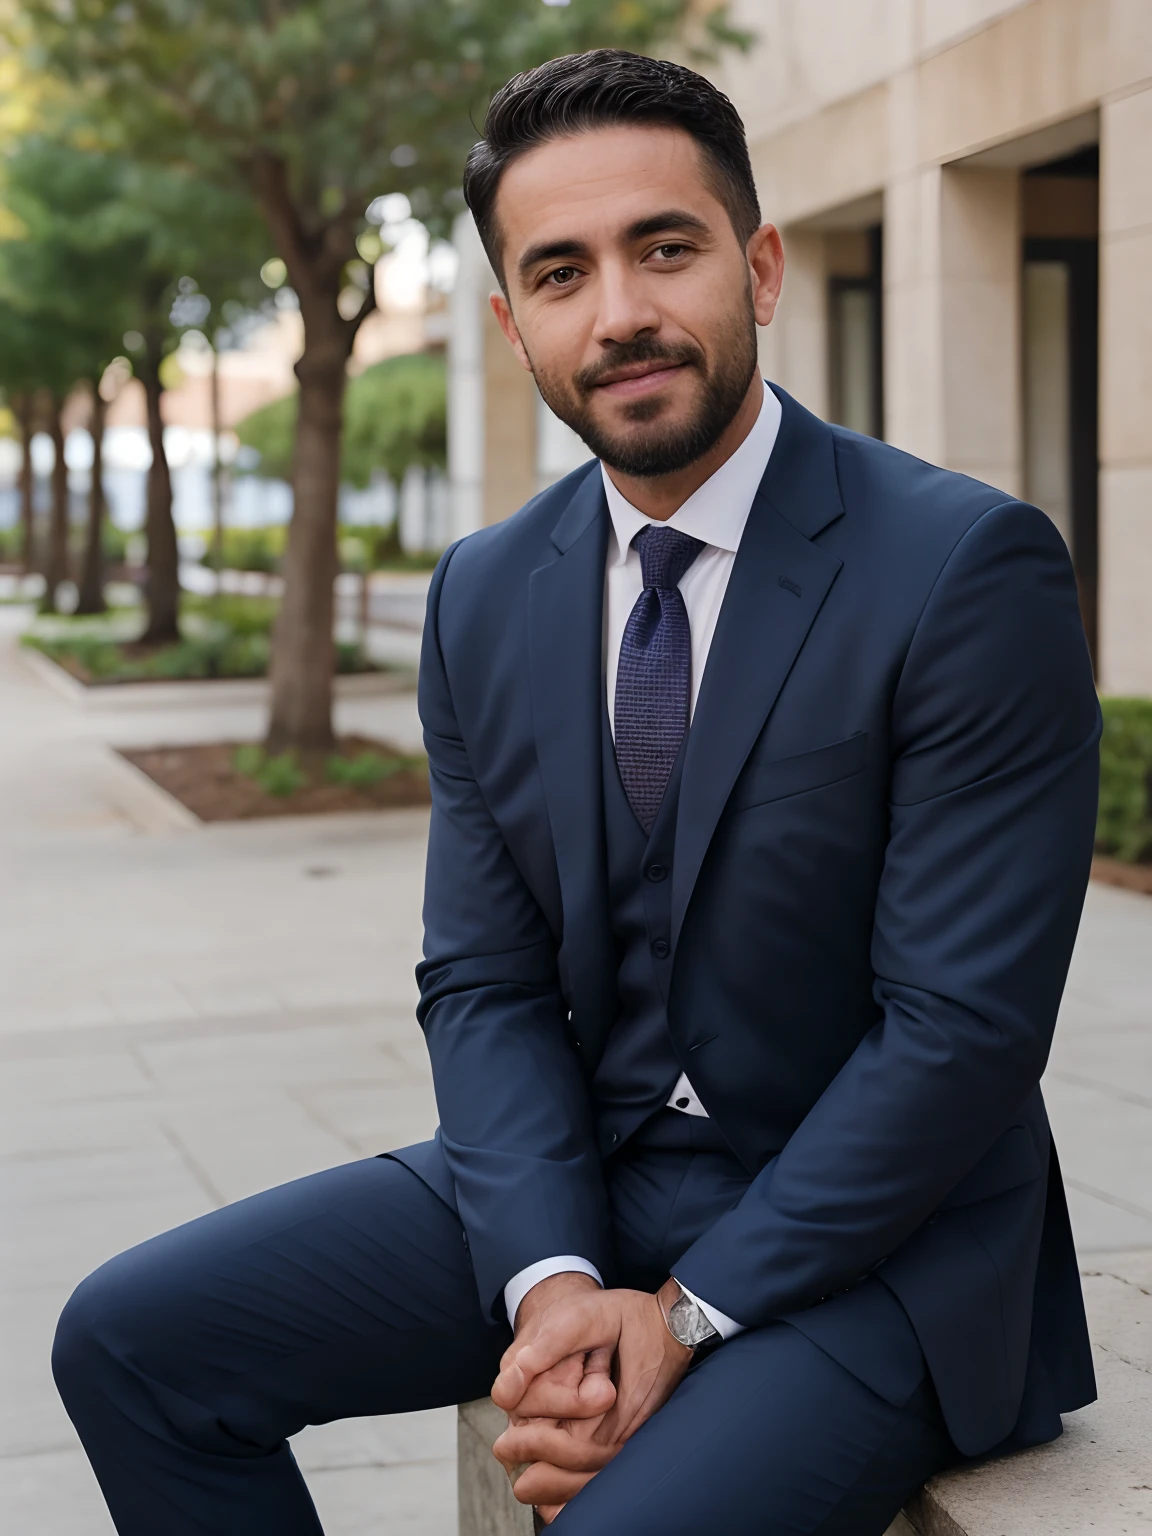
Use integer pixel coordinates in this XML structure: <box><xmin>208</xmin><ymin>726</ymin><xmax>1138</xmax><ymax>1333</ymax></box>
<box><xmin>828</xmin><ymin>224</ymin><xmax>883</xmax><ymax>438</ymax></box>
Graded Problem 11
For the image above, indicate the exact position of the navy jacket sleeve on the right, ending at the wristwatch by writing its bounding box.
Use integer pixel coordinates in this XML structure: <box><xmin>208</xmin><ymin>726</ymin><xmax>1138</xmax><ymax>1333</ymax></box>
<box><xmin>676</xmin><ymin>502</ymin><xmax>1100</xmax><ymax>1326</ymax></box>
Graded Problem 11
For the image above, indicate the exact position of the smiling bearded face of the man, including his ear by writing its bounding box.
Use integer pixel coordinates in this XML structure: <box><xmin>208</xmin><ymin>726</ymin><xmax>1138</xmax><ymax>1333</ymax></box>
<box><xmin>493</xmin><ymin>127</ymin><xmax>779</xmax><ymax>476</ymax></box>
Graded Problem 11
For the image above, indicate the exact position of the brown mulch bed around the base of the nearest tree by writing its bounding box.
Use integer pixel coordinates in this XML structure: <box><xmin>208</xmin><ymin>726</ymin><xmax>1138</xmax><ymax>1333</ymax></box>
<box><xmin>120</xmin><ymin>736</ymin><xmax>432</xmax><ymax>822</ymax></box>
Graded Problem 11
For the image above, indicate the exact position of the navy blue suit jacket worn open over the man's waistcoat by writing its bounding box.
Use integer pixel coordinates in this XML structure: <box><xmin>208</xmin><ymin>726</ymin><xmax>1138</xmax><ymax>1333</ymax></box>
<box><xmin>401</xmin><ymin>390</ymin><xmax>1100</xmax><ymax>1453</ymax></box>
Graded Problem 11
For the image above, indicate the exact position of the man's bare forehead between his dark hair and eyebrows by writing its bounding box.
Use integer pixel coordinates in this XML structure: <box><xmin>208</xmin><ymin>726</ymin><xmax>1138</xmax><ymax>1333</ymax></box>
<box><xmin>496</xmin><ymin>124</ymin><xmax>727</xmax><ymax>272</ymax></box>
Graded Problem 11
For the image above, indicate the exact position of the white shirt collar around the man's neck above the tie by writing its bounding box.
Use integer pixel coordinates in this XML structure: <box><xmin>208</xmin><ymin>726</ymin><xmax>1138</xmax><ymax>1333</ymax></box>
<box><xmin>601</xmin><ymin>377</ymin><xmax>782</xmax><ymax>565</ymax></box>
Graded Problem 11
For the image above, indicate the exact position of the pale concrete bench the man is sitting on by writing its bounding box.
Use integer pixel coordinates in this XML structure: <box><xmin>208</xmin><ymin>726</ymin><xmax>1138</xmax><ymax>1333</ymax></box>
<box><xmin>459</xmin><ymin>1252</ymin><xmax>1152</xmax><ymax>1536</ymax></box>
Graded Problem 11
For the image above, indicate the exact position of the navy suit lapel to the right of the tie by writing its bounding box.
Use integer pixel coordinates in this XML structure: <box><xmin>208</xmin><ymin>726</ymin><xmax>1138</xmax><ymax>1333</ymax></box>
<box><xmin>671</xmin><ymin>390</ymin><xmax>843</xmax><ymax>945</ymax></box>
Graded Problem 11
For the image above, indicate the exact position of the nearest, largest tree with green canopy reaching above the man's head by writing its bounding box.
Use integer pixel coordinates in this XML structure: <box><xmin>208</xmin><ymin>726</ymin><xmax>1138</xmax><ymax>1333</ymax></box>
<box><xmin>22</xmin><ymin>0</ymin><xmax>734</xmax><ymax>750</ymax></box>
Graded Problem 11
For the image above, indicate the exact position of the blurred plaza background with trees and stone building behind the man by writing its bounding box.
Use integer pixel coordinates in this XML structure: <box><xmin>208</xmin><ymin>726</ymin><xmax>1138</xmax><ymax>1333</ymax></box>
<box><xmin>0</xmin><ymin>0</ymin><xmax>1152</xmax><ymax>1536</ymax></box>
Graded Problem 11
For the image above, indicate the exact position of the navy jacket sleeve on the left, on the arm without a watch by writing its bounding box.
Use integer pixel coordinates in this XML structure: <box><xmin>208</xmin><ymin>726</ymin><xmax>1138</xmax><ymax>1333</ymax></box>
<box><xmin>416</xmin><ymin>550</ymin><xmax>610</xmax><ymax>1318</ymax></box>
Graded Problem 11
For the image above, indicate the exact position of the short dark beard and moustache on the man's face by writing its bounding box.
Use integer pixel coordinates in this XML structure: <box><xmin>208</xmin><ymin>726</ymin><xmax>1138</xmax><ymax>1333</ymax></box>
<box><xmin>533</xmin><ymin>293</ymin><xmax>768</xmax><ymax>479</ymax></box>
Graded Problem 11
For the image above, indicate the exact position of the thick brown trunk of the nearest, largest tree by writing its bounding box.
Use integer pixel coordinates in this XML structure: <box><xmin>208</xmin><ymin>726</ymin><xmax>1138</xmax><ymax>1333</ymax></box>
<box><xmin>267</xmin><ymin>342</ymin><xmax>350</xmax><ymax>753</ymax></box>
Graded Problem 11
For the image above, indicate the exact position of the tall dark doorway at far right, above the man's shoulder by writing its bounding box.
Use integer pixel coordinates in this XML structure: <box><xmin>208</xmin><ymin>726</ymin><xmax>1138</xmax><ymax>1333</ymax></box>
<box><xmin>1021</xmin><ymin>147</ymin><xmax>1100</xmax><ymax>660</ymax></box>
